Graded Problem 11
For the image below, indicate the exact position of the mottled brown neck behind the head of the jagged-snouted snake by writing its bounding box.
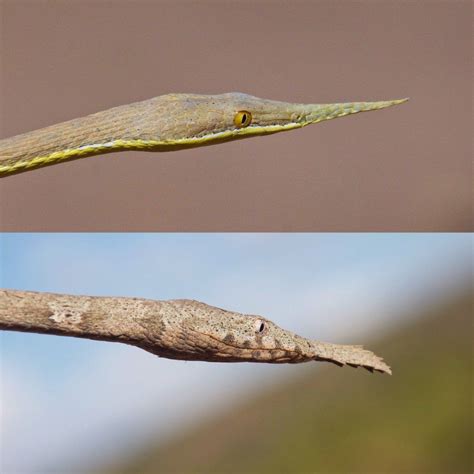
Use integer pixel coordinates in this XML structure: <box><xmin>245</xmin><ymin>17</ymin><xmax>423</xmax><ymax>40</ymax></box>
<box><xmin>0</xmin><ymin>290</ymin><xmax>205</xmax><ymax>360</ymax></box>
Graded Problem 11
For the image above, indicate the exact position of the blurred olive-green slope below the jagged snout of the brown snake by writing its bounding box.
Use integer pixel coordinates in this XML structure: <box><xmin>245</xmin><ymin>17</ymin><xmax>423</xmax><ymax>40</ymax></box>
<box><xmin>110</xmin><ymin>290</ymin><xmax>473</xmax><ymax>474</ymax></box>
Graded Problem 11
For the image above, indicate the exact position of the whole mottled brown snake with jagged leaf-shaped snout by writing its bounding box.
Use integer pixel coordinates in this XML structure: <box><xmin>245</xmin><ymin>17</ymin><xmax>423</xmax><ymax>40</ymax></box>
<box><xmin>0</xmin><ymin>290</ymin><xmax>391</xmax><ymax>374</ymax></box>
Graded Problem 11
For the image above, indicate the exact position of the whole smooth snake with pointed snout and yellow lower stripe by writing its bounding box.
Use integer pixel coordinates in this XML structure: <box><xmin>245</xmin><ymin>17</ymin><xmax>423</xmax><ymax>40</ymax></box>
<box><xmin>0</xmin><ymin>93</ymin><xmax>406</xmax><ymax>177</ymax></box>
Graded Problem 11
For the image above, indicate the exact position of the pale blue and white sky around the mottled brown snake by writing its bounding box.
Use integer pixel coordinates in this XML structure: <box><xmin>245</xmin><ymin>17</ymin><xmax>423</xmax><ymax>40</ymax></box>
<box><xmin>0</xmin><ymin>234</ymin><xmax>471</xmax><ymax>472</ymax></box>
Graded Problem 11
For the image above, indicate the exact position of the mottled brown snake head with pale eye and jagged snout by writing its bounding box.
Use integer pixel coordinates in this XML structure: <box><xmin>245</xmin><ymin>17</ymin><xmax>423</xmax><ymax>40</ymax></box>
<box><xmin>143</xmin><ymin>300</ymin><xmax>391</xmax><ymax>373</ymax></box>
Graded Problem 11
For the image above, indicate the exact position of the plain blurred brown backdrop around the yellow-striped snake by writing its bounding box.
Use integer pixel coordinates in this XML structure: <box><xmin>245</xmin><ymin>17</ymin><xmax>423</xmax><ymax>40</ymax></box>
<box><xmin>0</xmin><ymin>0</ymin><xmax>472</xmax><ymax>231</ymax></box>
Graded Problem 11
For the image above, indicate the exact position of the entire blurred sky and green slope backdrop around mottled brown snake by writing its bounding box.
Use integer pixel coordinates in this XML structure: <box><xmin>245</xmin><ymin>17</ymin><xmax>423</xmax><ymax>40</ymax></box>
<box><xmin>0</xmin><ymin>233</ymin><xmax>473</xmax><ymax>474</ymax></box>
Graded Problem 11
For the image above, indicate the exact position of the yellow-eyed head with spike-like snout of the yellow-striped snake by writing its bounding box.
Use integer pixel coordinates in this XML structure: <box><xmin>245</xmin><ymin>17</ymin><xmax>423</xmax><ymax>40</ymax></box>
<box><xmin>150</xmin><ymin>92</ymin><xmax>407</xmax><ymax>148</ymax></box>
